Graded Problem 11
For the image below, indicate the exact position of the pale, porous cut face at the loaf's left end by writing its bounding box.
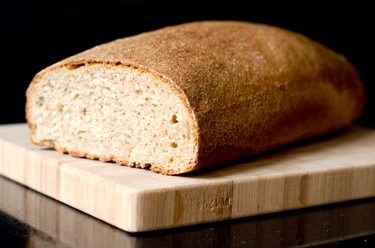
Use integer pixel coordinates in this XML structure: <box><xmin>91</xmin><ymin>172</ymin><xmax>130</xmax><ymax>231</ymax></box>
<box><xmin>27</xmin><ymin>64</ymin><xmax>197</xmax><ymax>174</ymax></box>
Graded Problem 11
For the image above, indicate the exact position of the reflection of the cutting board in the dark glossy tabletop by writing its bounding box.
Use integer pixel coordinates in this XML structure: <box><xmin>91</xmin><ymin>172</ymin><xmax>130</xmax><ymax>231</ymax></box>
<box><xmin>0</xmin><ymin>176</ymin><xmax>375</xmax><ymax>248</ymax></box>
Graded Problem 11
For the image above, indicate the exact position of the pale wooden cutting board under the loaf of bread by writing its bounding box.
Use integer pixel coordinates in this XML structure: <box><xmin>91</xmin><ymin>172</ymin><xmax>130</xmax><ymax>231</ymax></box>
<box><xmin>0</xmin><ymin>124</ymin><xmax>375</xmax><ymax>232</ymax></box>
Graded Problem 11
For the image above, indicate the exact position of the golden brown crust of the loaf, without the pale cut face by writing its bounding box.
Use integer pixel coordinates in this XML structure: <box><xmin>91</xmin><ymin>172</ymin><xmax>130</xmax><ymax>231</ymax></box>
<box><xmin>26</xmin><ymin>21</ymin><xmax>364</xmax><ymax>174</ymax></box>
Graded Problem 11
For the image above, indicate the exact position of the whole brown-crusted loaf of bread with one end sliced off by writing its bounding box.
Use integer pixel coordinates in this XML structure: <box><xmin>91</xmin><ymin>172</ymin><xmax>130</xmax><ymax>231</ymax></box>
<box><xmin>26</xmin><ymin>21</ymin><xmax>365</xmax><ymax>175</ymax></box>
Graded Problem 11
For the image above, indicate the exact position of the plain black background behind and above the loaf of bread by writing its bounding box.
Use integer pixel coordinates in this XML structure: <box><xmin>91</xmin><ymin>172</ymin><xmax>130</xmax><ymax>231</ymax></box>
<box><xmin>0</xmin><ymin>0</ymin><xmax>375</xmax><ymax>127</ymax></box>
